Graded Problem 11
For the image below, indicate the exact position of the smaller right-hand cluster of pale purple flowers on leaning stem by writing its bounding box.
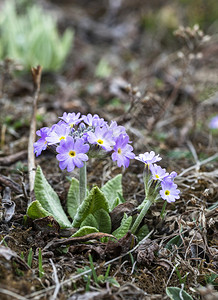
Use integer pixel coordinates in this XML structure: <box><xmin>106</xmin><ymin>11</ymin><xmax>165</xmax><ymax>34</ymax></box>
<box><xmin>135</xmin><ymin>151</ymin><xmax>180</xmax><ymax>203</ymax></box>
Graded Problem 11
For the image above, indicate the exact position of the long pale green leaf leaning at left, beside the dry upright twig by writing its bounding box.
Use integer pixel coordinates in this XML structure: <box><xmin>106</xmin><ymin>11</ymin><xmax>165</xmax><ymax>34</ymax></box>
<box><xmin>34</xmin><ymin>166</ymin><xmax>72</xmax><ymax>228</ymax></box>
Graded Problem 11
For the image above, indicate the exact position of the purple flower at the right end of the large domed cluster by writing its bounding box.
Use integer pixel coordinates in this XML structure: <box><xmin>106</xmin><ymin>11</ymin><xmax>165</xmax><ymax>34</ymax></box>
<box><xmin>112</xmin><ymin>134</ymin><xmax>135</xmax><ymax>168</ymax></box>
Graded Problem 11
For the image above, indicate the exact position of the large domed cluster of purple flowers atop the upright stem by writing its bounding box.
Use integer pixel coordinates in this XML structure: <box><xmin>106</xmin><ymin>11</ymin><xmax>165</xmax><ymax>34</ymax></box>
<box><xmin>34</xmin><ymin>112</ymin><xmax>135</xmax><ymax>172</ymax></box>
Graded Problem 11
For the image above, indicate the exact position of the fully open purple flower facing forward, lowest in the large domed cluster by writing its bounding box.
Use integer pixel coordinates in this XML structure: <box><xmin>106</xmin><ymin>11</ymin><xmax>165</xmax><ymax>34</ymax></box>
<box><xmin>56</xmin><ymin>136</ymin><xmax>89</xmax><ymax>172</ymax></box>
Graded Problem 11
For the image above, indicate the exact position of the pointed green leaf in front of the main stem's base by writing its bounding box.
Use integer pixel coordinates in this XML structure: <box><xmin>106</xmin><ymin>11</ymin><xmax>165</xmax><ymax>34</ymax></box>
<box><xmin>72</xmin><ymin>187</ymin><xmax>109</xmax><ymax>227</ymax></box>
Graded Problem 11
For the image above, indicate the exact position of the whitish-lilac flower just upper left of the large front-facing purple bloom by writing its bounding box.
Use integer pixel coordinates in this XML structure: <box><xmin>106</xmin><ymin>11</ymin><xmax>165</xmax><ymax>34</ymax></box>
<box><xmin>46</xmin><ymin>123</ymin><xmax>70</xmax><ymax>145</ymax></box>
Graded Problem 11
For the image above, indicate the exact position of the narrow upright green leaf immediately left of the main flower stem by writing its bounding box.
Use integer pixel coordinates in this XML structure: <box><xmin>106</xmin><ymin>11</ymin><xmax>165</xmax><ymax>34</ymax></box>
<box><xmin>67</xmin><ymin>178</ymin><xmax>80</xmax><ymax>219</ymax></box>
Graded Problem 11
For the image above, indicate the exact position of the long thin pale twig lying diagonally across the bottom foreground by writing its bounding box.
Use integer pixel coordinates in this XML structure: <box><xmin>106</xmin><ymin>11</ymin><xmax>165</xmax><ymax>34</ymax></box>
<box><xmin>27</xmin><ymin>229</ymin><xmax>154</xmax><ymax>299</ymax></box>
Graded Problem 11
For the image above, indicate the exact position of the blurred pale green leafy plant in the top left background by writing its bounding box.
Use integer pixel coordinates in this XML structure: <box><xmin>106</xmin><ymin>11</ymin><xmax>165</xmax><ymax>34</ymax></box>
<box><xmin>0</xmin><ymin>0</ymin><xmax>73</xmax><ymax>71</ymax></box>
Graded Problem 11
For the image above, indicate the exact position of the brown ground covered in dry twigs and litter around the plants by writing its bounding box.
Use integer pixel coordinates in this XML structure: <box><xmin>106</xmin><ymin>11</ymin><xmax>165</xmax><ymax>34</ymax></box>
<box><xmin>0</xmin><ymin>0</ymin><xmax>218</xmax><ymax>299</ymax></box>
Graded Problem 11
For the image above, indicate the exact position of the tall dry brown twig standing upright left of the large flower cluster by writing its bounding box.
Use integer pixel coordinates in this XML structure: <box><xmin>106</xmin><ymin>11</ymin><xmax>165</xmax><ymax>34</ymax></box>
<box><xmin>28</xmin><ymin>66</ymin><xmax>42</xmax><ymax>202</ymax></box>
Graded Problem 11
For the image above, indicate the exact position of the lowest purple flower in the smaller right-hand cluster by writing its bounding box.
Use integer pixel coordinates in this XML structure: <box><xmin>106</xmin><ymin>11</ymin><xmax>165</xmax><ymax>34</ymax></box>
<box><xmin>160</xmin><ymin>179</ymin><xmax>180</xmax><ymax>203</ymax></box>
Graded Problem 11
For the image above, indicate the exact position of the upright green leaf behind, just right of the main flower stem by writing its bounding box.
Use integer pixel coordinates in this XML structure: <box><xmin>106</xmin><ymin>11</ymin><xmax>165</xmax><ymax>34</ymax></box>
<box><xmin>101</xmin><ymin>174</ymin><xmax>123</xmax><ymax>211</ymax></box>
